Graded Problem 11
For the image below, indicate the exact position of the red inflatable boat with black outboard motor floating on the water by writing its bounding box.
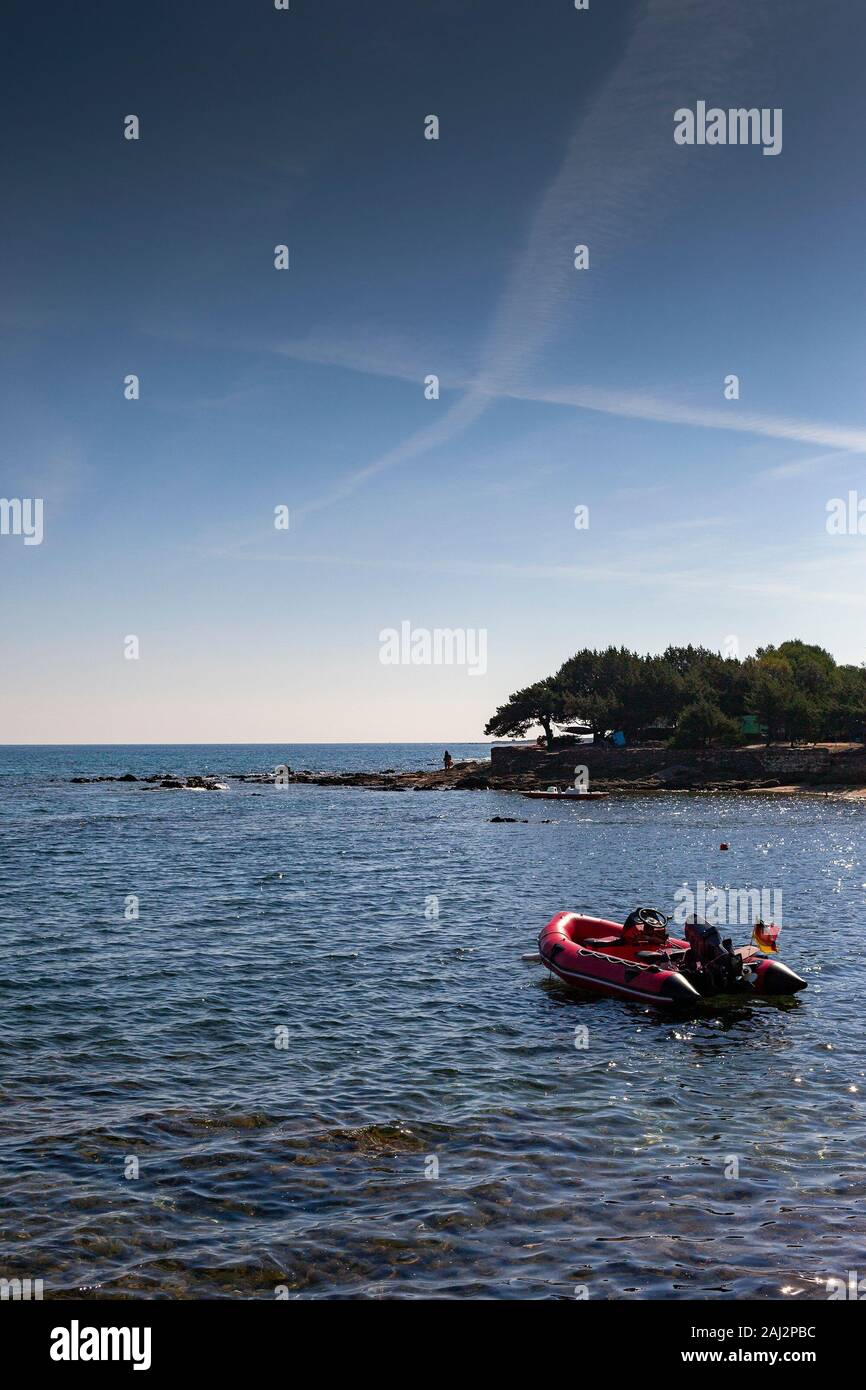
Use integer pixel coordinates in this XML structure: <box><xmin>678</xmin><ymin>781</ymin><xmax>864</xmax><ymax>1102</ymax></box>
<box><xmin>538</xmin><ymin>908</ymin><xmax>806</xmax><ymax>1005</ymax></box>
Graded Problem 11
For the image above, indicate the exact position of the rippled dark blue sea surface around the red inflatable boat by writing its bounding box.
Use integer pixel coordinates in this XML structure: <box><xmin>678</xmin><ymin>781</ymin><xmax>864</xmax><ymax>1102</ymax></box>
<box><xmin>0</xmin><ymin>745</ymin><xmax>866</xmax><ymax>1298</ymax></box>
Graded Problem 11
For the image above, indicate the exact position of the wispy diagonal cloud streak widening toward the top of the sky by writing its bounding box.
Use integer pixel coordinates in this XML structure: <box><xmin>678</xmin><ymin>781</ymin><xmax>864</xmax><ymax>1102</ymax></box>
<box><xmin>289</xmin><ymin>0</ymin><xmax>748</xmax><ymax>513</ymax></box>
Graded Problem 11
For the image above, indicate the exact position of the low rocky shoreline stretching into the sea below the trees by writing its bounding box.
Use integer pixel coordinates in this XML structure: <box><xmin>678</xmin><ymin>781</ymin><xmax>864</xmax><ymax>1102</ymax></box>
<box><xmin>70</xmin><ymin>759</ymin><xmax>866</xmax><ymax>799</ymax></box>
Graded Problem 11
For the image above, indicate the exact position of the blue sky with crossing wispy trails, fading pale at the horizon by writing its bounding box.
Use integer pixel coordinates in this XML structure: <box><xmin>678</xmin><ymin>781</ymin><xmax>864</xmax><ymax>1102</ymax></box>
<box><xmin>0</xmin><ymin>0</ymin><xmax>866</xmax><ymax>742</ymax></box>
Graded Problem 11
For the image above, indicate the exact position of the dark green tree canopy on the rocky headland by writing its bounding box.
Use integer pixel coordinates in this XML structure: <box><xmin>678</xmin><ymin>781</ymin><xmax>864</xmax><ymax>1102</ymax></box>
<box><xmin>484</xmin><ymin>639</ymin><xmax>866</xmax><ymax>748</ymax></box>
